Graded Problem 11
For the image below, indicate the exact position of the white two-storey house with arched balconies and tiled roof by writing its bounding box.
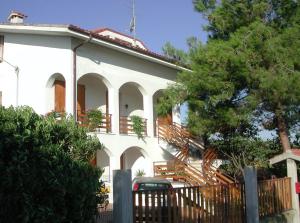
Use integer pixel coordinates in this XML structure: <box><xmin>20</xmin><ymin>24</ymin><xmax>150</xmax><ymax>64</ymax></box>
<box><xmin>0</xmin><ymin>12</ymin><xmax>232</xmax><ymax>201</ymax></box>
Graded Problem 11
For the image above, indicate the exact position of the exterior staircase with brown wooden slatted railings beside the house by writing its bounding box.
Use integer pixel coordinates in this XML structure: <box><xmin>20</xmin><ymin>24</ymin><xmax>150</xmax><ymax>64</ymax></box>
<box><xmin>154</xmin><ymin>120</ymin><xmax>235</xmax><ymax>186</ymax></box>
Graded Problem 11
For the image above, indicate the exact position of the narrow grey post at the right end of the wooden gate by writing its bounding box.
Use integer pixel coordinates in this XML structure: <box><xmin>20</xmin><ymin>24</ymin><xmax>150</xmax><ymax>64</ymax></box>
<box><xmin>244</xmin><ymin>166</ymin><xmax>259</xmax><ymax>223</ymax></box>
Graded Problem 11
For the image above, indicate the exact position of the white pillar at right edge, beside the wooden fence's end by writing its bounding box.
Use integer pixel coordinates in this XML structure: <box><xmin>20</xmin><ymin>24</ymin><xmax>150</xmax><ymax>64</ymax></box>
<box><xmin>286</xmin><ymin>159</ymin><xmax>300</xmax><ymax>223</ymax></box>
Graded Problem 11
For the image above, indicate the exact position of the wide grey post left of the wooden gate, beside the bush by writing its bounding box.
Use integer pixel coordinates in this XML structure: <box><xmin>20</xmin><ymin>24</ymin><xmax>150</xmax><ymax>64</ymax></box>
<box><xmin>113</xmin><ymin>170</ymin><xmax>133</xmax><ymax>223</ymax></box>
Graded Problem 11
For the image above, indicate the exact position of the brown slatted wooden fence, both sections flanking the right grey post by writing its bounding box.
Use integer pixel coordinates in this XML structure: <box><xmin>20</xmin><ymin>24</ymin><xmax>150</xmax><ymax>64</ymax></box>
<box><xmin>133</xmin><ymin>178</ymin><xmax>291</xmax><ymax>223</ymax></box>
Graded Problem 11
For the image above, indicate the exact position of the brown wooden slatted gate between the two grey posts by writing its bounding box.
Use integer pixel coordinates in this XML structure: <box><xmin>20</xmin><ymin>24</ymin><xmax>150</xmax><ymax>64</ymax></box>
<box><xmin>133</xmin><ymin>185</ymin><xmax>244</xmax><ymax>223</ymax></box>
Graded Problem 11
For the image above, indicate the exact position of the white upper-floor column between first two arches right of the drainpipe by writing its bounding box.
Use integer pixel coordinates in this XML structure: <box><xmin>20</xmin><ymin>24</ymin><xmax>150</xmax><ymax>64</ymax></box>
<box><xmin>108</xmin><ymin>88</ymin><xmax>119</xmax><ymax>134</ymax></box>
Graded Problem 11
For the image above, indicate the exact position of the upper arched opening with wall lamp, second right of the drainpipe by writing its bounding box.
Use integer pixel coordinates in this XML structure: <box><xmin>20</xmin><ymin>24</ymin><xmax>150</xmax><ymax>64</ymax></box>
<box><xmin>119</xmin><ymin>82</ymin><xmax>146</xmax><ymax>134</ymax></box>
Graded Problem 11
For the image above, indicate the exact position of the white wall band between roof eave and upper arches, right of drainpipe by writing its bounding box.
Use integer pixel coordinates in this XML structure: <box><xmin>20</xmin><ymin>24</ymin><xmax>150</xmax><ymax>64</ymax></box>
<box><xmin>73</xmin><ymin>42</ymin><xmax>177</xmax><ymax>95</ymax></box>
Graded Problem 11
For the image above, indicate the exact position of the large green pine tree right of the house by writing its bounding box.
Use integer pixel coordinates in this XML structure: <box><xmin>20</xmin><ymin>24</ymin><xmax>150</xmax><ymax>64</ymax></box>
<box><xmin>158</xmin><ymin>0</ymin><xmax>300</xmax><ymax>174</ymax></box>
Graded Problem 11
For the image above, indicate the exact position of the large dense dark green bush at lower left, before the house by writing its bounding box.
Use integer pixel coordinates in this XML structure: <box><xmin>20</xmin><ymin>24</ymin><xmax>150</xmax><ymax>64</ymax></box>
<box><xmin>0</xmin><ymin>107</ymin><xmax>101</xmax><ymax>223</ymax></box>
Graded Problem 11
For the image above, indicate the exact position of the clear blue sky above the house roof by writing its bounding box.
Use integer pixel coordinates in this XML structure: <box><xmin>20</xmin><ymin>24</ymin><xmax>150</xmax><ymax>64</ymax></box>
<box><xmin>0</xmin><ymin>0</ymin><xmax>206</xmax><ymax>53</ymax></box>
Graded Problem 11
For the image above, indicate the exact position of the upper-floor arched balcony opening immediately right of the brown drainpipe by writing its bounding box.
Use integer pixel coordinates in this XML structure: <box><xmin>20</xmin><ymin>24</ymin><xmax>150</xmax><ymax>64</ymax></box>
<box><xmin>77</xmin><ymin>73</ymin><xmax>111</xmax><ymax>132</ymax></box>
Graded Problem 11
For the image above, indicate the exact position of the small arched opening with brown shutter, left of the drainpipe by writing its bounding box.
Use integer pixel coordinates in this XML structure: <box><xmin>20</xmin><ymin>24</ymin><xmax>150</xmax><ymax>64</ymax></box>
<box><xmin>46</xmin><ymin>73</ymin><xmax>66</xmax><ymax>113</ymax></box>
